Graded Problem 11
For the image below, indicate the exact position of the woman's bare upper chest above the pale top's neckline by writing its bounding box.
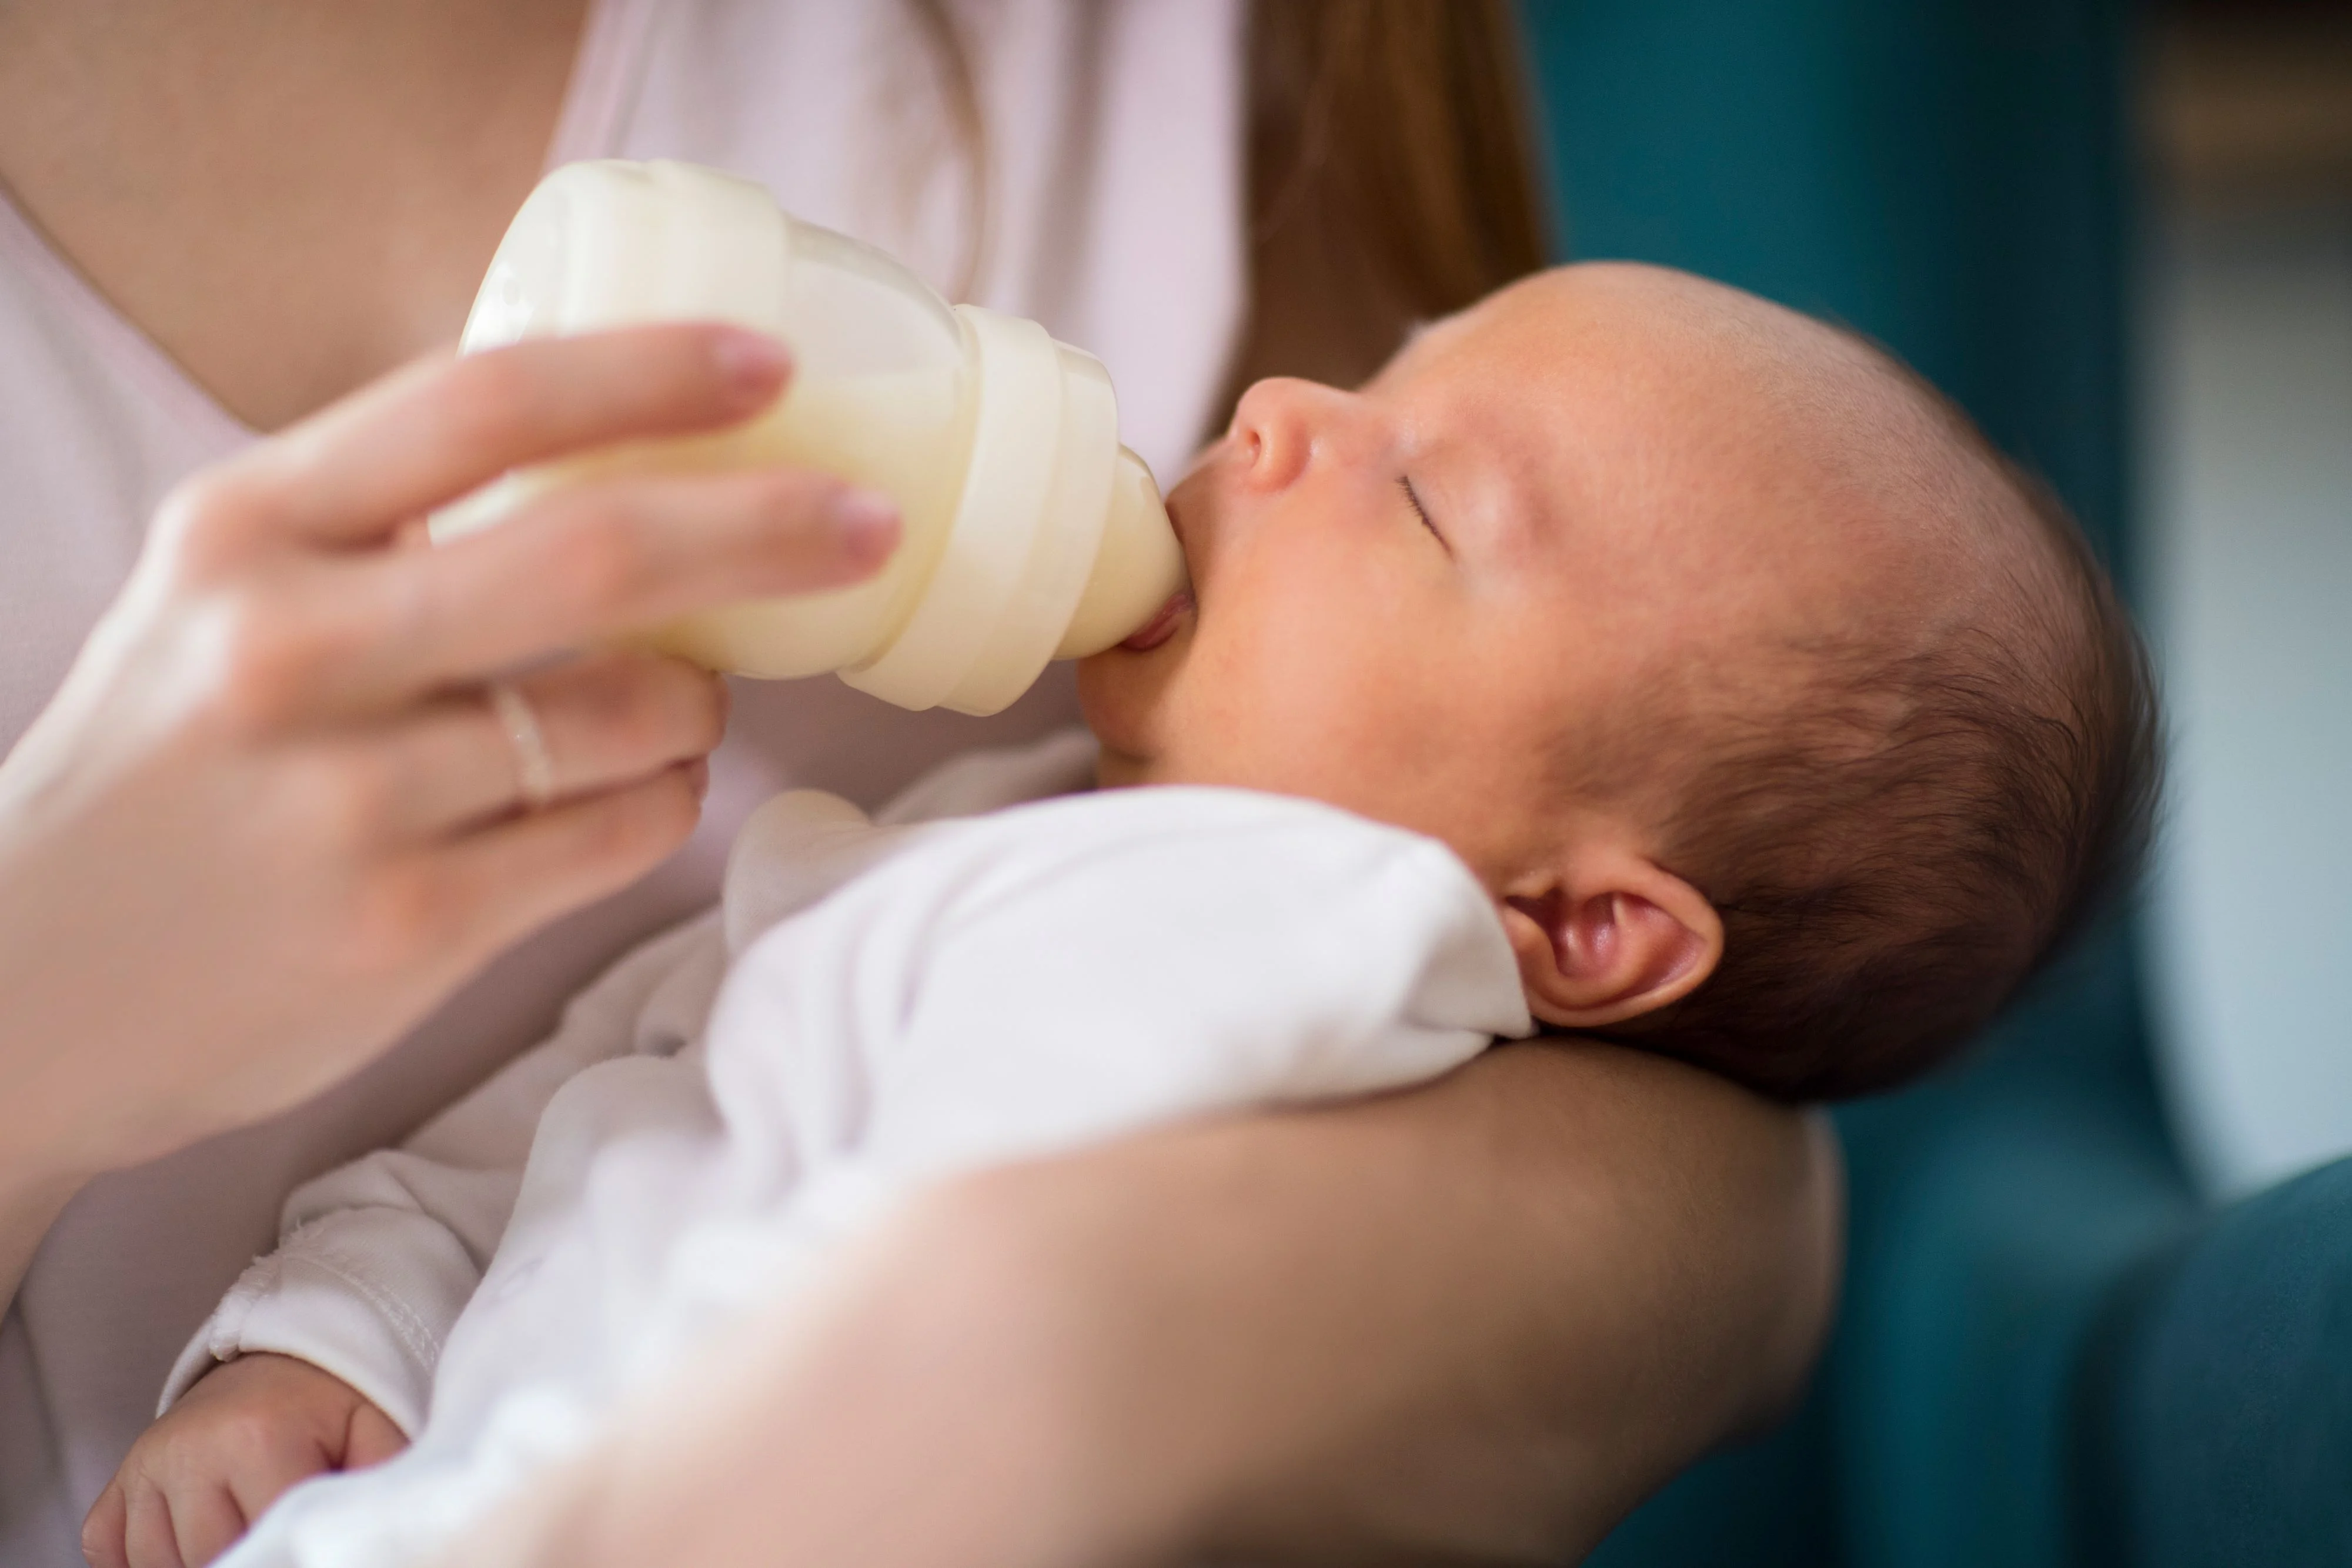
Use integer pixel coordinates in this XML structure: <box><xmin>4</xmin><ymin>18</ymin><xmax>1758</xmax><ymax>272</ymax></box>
<box><xmin>0</xmin><ymin>0</ymin><xmax>588</xmax><ymax>430</ymax></box>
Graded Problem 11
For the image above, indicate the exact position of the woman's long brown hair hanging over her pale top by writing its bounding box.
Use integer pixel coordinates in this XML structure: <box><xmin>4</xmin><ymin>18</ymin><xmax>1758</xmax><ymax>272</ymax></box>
<box><xmin>913</xmin><ymin>0</ymin><xmax>1548</xmax><ymax>419</ymax></box>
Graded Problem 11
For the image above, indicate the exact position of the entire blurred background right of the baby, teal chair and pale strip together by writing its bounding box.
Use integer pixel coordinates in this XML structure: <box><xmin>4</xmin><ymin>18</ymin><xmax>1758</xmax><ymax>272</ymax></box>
<box><xmin>1522</xmin><ymin>0</ymin><xmax>2352</xmax><ymax>1568</ymax></box>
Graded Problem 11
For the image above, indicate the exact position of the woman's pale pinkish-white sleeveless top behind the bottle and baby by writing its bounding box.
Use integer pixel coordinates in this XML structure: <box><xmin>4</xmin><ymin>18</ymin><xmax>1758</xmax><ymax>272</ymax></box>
<box><xmin>0</xmin><ymin>0</ymin><xmax>1244</xmax><ymax>1568</ymax></box>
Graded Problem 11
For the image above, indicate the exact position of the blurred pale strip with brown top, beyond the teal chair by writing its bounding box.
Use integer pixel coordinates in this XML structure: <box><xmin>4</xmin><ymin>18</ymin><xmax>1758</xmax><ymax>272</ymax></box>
<box><xmin>2133</xmin><ymin>0</ymin><xmax>2352</xmax><ymax>1203</ymax></box>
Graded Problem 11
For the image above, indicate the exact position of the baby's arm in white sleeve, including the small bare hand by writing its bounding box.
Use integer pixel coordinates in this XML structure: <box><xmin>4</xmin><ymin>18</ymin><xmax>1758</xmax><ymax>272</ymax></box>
<box><xmin>82</xmin><ymin>914</ymin><xmax>724</xmax><ymax>1568</ymax></box>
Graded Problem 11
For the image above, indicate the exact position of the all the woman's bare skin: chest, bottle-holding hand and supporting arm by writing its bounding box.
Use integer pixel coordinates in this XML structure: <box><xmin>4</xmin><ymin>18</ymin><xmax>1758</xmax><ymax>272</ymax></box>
<box><xmin>0</xmin><ymin>0</ymin><xmax>1837</xmax><ymax>1568</ymax></box>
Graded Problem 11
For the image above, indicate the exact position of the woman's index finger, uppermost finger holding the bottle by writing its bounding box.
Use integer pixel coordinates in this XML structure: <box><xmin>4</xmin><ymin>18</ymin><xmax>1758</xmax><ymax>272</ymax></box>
<box><xmin>223</xmin><ymin>322</ymin><xmax>790</xmax><ymax>546</ymax></box>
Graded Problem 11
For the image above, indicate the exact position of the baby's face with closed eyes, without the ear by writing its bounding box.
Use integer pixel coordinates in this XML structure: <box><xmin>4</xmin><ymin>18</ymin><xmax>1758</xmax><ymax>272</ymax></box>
<box><xmin>1080</xmin><ymin>266</ymin><xmax>1917</xmax><ymax>895</ymax></box>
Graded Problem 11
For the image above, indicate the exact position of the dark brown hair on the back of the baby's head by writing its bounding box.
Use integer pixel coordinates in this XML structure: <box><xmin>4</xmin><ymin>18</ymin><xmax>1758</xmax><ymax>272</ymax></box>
<box><xmin>1599</xmin><ymin>355</ymin><xmax>2161</xmax><ymax>1100</ymax></box>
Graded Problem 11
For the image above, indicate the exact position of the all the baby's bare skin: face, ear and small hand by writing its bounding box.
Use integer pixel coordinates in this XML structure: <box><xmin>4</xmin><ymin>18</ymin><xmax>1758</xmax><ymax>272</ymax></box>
<box><xmin>82</xmin><ymin>266</ymin><xmax>2030</xmax><ymax>1568</ymax></box>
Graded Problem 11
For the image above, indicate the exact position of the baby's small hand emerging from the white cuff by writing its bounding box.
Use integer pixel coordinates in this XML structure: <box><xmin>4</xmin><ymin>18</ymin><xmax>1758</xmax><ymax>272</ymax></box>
<box><xmin>82</xmin><ymin>1354</ymin><xmax>407</xmax><ymax>1568</ymax></box>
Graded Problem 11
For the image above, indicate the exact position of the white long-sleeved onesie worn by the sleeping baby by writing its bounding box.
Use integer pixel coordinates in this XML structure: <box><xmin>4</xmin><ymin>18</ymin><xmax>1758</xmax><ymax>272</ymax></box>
<box><xmin>165</xmin><ymin>736</ymin><xmax>1531</xmax><ymax>1568</ymax></box>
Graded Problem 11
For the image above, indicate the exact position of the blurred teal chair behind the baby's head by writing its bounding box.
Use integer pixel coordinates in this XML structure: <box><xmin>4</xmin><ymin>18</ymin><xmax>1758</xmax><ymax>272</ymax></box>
<box><xmin>1522</xmin><ymin>0</ymin><xmax>2352</xmax><ymax>1568</ymax></box>
